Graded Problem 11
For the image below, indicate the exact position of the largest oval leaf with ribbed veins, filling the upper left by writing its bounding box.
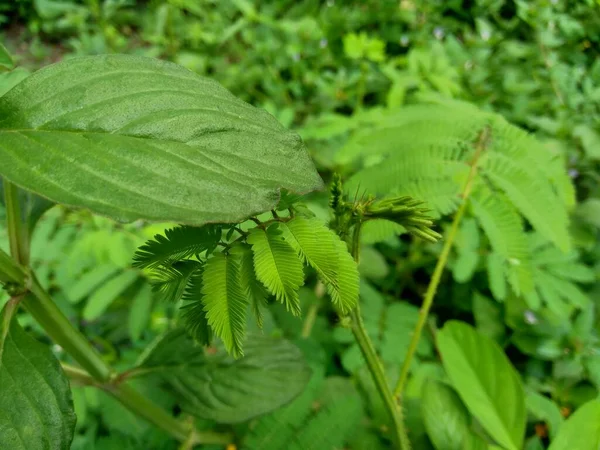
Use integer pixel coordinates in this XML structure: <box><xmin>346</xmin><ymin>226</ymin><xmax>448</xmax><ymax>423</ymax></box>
<box><xmin>0</xmin><ymin>55</ymin><xmax>322</xmax><ymax>225</ymax></box>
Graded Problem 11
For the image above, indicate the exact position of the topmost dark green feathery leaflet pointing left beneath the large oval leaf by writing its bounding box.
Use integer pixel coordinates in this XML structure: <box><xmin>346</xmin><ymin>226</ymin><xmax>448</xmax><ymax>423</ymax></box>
<box><xmin>133</xmin><ymin>225</ymin><xmax>221</xmax><ymax>268</ymax></box>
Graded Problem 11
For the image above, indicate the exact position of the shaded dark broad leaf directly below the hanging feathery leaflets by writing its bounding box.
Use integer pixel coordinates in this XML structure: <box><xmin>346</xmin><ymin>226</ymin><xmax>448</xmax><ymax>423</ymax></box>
<box><xmin>138</xmin><ymin>330</ymin><xmax>311</xmax><ymax>423</ymax></box>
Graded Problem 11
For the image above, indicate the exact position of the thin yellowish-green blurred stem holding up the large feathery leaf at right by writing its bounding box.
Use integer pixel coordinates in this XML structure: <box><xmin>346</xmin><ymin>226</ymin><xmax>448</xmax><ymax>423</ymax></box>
<box><xmin>394</xmin><ymin>128</ymin><xmax>489</xmax><ymax>404</ymax></box>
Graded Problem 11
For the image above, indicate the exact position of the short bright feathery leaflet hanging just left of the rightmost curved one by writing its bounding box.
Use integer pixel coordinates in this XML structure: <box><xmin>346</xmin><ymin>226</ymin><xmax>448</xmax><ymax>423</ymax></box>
<box><xmin>248</xmin><ymin>224</ymin><xmax>304</xmax><ymax>315</ymax></box>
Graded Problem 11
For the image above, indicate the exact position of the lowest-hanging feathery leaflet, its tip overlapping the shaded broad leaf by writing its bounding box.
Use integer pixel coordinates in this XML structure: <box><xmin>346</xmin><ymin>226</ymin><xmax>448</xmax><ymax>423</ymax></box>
<box><xmin>202</xmin><ymin>253</ymin><xmax>248</xmax><ymax>358</ymax></box>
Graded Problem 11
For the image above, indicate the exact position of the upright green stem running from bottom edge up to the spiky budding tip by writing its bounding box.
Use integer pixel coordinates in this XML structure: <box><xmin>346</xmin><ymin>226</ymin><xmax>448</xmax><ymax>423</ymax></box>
<box><xmin>350</xmin><ymin>222</ymin><xmax>411</xmax><ymax>450</ymax></box>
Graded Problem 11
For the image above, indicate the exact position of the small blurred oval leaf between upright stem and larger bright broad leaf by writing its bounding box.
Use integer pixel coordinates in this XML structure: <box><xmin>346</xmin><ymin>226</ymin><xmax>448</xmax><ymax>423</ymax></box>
<box><xmin>421</xmin><ymin>380</ymin><xmax>486</xmax><ymax>450</ymax></box>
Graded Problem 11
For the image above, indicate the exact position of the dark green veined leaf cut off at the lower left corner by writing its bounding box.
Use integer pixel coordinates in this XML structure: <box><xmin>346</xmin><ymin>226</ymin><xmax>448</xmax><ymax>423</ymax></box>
<box><xmin>0</xmin><ymin>302</ymin><xmax>76</xmax><ymax>450</ymax></box>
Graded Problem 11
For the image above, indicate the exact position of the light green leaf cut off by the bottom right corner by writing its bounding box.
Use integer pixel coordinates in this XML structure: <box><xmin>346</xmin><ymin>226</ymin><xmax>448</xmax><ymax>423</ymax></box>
<box><xmin>548</xmin><ymin>400</ymin><xmax>600</xmax><ymax>450</ymax></box>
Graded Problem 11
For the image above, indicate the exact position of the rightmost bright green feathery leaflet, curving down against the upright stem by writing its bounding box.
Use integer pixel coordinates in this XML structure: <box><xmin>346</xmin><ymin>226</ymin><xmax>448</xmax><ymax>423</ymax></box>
<box><xmin>281</xmin><ymin>217</ymin><xmax>359</xmax><ymax>314</ymax></box>
